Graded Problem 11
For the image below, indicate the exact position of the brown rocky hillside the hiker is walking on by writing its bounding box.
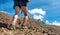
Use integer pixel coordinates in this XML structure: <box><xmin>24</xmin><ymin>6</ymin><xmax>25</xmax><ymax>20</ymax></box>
<box><xmin>0</xmin><ymin>12</ymin><xmax>60</xmax><ymax>35</ymax></box>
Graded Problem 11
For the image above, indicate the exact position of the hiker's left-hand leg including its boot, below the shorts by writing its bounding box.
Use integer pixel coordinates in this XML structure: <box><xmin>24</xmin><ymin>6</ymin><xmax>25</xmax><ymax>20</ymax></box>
<box><xmin>8</xmin><ymin>6</ymin><xmax>20</xmax><ymax>29</ymax></box>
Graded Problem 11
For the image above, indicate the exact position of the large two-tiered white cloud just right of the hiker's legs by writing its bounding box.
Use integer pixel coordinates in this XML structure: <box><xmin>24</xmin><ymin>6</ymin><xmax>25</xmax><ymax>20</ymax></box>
<box><xmin>29</xmin><ymin>8</ymin><xmax>46</xmax><ymax>21</ymax></box>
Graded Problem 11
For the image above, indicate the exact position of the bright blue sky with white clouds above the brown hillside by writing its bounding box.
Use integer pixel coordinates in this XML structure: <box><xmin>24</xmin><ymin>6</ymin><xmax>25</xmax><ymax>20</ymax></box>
<box><xmin>0</xmin><ymin>0</ymin><xmax>60</xmax><ymax>26</ymax></box>
